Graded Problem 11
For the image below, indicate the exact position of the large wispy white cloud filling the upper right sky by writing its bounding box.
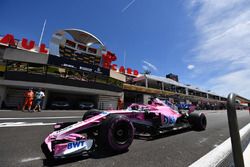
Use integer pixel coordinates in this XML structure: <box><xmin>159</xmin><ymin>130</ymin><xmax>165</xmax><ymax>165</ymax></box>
<box><xmin>188</xmin><ymin>0</ymin><xmax>250</xmax><ymax>98</ymax></box>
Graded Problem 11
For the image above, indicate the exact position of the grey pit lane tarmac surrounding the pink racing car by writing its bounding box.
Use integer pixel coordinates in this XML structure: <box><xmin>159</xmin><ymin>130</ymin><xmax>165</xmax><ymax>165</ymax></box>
<box><xmin>0</xmin><ymin>111</ymin><xmax>250</xmax><ymax>167</ymax></box>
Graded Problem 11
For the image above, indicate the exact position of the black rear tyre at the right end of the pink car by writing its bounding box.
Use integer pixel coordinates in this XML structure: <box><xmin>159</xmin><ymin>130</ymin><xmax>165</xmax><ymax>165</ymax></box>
<box><xmin>188</xmin><ymin>113</ymin><xmax>207</xmax><ymax>131</ymax></box>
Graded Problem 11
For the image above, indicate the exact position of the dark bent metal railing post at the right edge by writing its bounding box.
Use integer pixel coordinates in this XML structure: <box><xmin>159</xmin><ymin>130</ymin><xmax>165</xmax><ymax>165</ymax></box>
<box><xmin>227</xmin><ymin>93</ymin><xmax>250</xmax><ymax>167</ymax></box>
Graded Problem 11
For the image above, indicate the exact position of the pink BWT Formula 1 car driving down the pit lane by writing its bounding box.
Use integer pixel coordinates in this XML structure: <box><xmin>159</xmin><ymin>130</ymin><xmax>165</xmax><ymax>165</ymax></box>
<box><xmin>41</xmin><ymin>98</ymin><xmax>207</xmax><ymax>159</ymax></box>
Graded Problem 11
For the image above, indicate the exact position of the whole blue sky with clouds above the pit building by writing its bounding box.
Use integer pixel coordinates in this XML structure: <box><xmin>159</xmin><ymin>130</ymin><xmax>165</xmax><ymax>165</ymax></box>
<box><xmin>0</xmin><ymin>0</ymin><xmax>250</xmax><ymax>97</ymax></box>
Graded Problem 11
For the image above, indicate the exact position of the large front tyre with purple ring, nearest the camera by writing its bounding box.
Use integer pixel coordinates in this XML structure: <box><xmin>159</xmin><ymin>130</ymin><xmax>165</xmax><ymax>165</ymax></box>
<box><xmin>98</xmin><ymin>114</ymin><xmax>134</xmax><ymax>152</ymax></box>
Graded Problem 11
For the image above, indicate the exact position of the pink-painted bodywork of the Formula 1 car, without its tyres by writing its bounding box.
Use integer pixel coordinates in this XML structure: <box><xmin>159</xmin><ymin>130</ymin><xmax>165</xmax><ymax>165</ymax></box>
<box><xmin>45</xmin><ymin>99</ymin><xmax>192</xmax><ymax>156</ymax></box>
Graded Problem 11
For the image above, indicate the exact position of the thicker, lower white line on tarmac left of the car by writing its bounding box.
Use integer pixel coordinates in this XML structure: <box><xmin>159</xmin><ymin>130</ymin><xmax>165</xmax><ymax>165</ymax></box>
<box><xmin>0</xmin><ymin>122</ymin><xmax>56</xmax><ymax>128</ymax></box>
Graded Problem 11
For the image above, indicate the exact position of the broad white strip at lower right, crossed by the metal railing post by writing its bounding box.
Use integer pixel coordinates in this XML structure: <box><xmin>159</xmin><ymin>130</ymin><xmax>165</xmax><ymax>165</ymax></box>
<box><xmin>189</xmin><ymin>123</ymin><xmax>250</xmax><ymax>167</ymax></box>
